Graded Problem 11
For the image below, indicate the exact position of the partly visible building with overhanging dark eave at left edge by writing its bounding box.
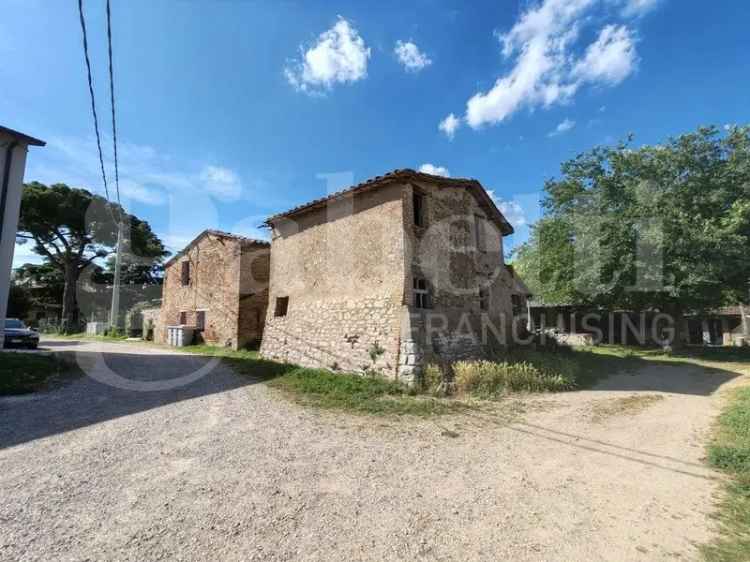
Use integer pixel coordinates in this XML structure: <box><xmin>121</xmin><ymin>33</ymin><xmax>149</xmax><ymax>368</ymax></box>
<box><xmin>0</xmin><ymin>126</ymin><xmax>45</xmax><ymax>348</ymax></box>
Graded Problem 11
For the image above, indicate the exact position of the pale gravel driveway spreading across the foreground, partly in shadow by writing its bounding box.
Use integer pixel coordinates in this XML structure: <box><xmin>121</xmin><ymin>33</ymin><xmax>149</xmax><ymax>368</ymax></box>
<box><xmin>0</xmin><ymin>341</ymin><xmax>734</xmax><ymax>562</ymax></box>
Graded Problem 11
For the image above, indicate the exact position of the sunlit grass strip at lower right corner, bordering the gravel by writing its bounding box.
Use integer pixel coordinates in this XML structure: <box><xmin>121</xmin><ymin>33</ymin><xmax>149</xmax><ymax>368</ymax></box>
<box><xmin>702</xmin><ymin>387</ymin><xmax>750</xmax><ymax>562</ymax></box>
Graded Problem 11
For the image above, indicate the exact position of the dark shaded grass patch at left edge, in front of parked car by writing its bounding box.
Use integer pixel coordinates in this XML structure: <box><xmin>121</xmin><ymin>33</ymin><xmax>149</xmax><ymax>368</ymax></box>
<box><xmin>0</xmin><ymin>352</ymin><xmax>75</xmax><ymax>396</ymax></box>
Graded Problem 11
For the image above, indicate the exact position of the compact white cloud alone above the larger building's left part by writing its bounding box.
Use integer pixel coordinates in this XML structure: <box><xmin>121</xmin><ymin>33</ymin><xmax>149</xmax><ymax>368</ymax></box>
<box><xmin>284</xmin><ymin>16</ymin><xmax>370</xmax><ymax>94</ymax></box>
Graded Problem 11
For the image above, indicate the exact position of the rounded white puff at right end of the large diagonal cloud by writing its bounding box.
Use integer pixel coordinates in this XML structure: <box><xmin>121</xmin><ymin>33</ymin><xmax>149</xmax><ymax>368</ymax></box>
<box><xmin>573</xmin><ymin>25</ymin><xmax>638</xmax><ymax>85</ymax></box>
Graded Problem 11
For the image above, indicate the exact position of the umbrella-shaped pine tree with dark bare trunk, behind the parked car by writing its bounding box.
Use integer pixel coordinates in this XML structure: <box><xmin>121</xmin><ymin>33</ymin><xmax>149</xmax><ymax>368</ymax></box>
<box><xmin>18</xmin><ymin>182</ymin><xmax>168</xmax><ymax>331</ymax></box>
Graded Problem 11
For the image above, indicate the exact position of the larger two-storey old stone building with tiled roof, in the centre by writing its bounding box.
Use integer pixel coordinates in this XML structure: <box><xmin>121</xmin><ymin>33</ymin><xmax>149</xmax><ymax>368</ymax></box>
<box><xmin>261</xmin><ymin>166</ymin><xmax>514</xmax><ymax>382</ymax></box>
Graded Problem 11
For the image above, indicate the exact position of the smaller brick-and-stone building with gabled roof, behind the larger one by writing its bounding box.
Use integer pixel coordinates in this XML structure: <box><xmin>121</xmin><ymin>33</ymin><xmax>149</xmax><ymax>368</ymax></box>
<box><xmin>154</xmin><ymin>230</ymin><xmax>269</xmax><ymax>349</ymax></box>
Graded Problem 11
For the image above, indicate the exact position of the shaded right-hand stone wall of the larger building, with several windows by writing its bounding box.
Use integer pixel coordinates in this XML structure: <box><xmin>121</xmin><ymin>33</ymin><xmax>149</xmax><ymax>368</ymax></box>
<box><xmin>400</xmin><ymin>183</ymin><xmax>514</xmax><ymax>376</ymax></box>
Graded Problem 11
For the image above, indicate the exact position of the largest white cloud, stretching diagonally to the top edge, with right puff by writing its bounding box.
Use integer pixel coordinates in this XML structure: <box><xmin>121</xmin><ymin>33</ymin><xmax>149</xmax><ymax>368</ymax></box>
<box><xmin>456</xmin><ymin>0</ymin><xmax>638</xmax><ymax>129</ymax></box>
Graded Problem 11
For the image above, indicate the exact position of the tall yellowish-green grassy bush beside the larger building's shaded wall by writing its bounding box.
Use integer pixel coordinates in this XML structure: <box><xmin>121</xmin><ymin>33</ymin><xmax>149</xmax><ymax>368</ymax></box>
<box><xmin>453</xmin><ymin>361</ymin><xmax>575</xmax><ymax>398</ymax></box>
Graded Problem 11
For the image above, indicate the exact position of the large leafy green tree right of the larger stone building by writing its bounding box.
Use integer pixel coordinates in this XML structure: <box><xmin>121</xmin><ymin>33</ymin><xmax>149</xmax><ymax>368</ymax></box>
<box><xmin>516</xmin><ymin>127</ymin><xmax>750</xmax><ymax>340</ymax></box>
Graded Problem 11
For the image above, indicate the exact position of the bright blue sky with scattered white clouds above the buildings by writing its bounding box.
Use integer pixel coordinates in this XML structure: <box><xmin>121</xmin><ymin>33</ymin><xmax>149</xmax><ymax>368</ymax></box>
<box><xmin>0</xmin><ymin>0</ymin><xmax>750</xmax><ymax>265</ymax></box>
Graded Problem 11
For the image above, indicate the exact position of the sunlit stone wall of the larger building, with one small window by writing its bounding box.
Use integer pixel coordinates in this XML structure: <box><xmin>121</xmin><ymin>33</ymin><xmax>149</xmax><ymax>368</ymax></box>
<box><xmin>261</xmin><ymin>185</ymin><xmax>412</xmax><ymax>376</ymax></box>
